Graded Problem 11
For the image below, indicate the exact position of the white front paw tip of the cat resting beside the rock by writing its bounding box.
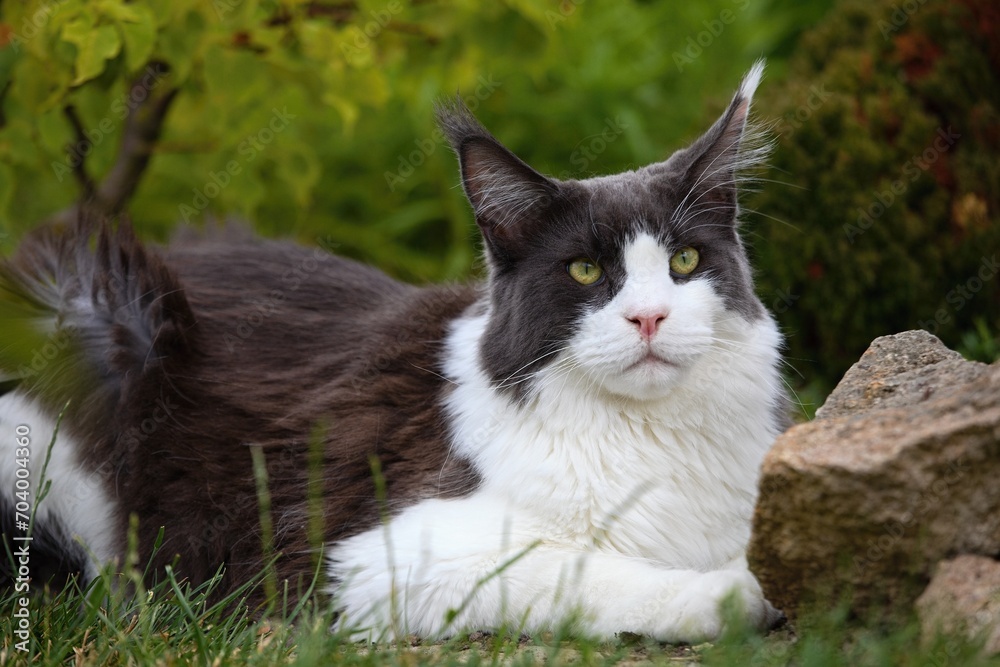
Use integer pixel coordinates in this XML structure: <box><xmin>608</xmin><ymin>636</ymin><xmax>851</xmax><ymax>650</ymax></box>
<box><xmin>657</xmin><ymin>570</ymin><xmax>782</xmax><ymax>644</ymax></box>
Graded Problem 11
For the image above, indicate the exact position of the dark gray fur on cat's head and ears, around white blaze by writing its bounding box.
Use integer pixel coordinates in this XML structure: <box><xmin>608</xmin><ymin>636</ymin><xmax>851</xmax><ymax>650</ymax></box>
<box><xmin>438</xmin><ymin>72</ymin><xmax>767</xmax><ymax>396</ymax></box>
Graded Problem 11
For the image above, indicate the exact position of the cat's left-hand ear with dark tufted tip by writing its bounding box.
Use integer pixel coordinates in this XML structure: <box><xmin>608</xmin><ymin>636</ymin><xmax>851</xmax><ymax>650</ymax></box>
<box><xmin>437</xmin><ymin>99</ymin><xmax>559</xmax><ymax>253</ymax></box>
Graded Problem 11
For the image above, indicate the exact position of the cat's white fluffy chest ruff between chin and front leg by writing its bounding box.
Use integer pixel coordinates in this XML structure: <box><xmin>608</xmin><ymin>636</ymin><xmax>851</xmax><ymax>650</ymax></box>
<box><xmin>448</xmin><ymin>312</ymin><xmax>777</xmax><ymax>570</ymax></box>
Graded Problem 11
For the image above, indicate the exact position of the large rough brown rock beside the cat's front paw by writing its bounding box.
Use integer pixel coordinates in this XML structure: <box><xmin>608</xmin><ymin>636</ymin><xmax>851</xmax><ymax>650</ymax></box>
<box><xmin>748</xmin><ymin>331</ymin><xmax>1000</xmax><ymax>619</ymax></box>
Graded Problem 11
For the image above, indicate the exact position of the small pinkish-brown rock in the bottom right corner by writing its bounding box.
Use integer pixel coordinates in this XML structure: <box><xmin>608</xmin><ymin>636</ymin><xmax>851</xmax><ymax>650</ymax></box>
<box><xmin>917</xmin><ymin>555</ymin><xmax>1000</xmax><ymax>654</ymax></box>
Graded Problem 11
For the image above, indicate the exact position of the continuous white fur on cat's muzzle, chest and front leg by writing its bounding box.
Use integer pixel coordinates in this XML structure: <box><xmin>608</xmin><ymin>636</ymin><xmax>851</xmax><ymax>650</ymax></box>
<box><xmin>330</xmin><ymin>235</ymin><xmax>780</xmax><ymax>641</ymax></box>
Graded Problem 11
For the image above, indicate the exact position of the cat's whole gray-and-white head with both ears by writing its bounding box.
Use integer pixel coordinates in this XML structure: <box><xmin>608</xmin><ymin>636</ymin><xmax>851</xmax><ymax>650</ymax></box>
<box><xmin>439</xmin><ymin>63</ymin><xmax>769</xmax><ymax>399</ymax></box>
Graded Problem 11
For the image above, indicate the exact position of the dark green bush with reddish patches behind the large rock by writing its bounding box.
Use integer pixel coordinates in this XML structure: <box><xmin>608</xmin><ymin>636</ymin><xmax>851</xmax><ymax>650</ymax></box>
<box><xmin>749</xmin><ymin>0</ymin><xmax>1000</xmax><ymax>387</ymax></box>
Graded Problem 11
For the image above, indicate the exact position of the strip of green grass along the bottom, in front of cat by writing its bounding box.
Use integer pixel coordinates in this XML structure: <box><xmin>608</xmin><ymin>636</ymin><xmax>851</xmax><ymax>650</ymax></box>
<box><xmin>0</xmin><ymin>568</ymin><xmax>1000</xmax><ymax>667</ymax></box>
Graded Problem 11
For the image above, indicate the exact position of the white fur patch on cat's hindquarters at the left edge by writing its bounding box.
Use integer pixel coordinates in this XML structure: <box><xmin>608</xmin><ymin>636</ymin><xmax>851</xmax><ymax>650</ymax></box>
<box><xmin>0</xmin><ymin>392</ymin><xmax>121</xmax><ymax>581</ymax></box>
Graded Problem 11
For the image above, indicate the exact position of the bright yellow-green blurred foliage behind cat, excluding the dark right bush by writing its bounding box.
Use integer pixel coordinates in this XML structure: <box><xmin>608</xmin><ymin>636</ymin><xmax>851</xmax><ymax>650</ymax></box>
<box><xmin>0</xmin><ymin>0</ymin><xmax>829</xmax><ymax>281</ymax></box>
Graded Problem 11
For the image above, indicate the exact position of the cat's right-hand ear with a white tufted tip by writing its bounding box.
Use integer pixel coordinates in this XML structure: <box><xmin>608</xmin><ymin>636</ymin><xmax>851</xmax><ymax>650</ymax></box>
<box><xmin>648</xmin><ymin>60</ymin><xmax>771</xmax><ymax>218</ymax></box>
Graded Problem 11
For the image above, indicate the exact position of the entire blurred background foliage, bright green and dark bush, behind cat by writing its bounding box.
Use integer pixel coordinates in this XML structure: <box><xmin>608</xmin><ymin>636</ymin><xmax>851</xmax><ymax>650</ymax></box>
<box><xmin>0</xmin><ymin>0</ymin><xmax>1000</xmax><ymax>414</ymax></box>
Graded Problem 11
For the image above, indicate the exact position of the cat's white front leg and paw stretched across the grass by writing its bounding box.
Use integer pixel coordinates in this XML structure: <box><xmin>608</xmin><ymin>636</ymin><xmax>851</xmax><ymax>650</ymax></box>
<box><xmin>331</xmin><ymin>498</ymin><xmax>776</xmax><ymax>643</ymax></box>
